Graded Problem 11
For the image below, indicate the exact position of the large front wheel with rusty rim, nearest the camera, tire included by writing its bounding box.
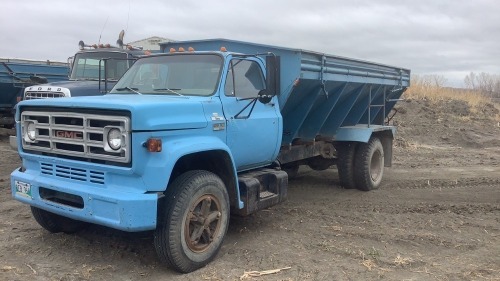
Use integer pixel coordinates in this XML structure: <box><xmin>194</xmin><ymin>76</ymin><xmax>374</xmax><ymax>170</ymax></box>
<box><xmin>154</xmin><ymin>170</ymin><xmax>229</xmax><ymax>273</ymax></box>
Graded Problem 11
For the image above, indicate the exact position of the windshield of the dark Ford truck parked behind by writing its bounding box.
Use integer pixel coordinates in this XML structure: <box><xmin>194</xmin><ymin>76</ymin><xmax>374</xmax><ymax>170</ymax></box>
<box><xmin>71</xmin><ymin>52</ymin><xmax>129</xmax><ymax>81</ymax></box>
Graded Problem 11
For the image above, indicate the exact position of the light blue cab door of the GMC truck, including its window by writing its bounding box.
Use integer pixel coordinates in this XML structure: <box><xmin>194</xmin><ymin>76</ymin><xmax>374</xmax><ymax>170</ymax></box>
<box><xmin>221</xmin><ymin>58</ymin><xmax>282</xmax><ymax>171</ymax></box>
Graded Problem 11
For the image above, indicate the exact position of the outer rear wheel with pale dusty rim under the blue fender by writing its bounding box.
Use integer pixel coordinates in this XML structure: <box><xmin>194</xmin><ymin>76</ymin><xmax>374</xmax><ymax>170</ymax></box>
<box><xmin>354</xmin><ymin>137</ymin><xmax>384</xmax><ymax>191</ymax></box>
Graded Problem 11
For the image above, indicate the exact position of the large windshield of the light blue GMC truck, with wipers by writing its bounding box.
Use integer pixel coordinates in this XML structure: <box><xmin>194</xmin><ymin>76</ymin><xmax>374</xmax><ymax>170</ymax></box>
<box><xmin>111</xmin><ymin>54</ymin><xmax>222</xmax><ymax>96</ymax></box>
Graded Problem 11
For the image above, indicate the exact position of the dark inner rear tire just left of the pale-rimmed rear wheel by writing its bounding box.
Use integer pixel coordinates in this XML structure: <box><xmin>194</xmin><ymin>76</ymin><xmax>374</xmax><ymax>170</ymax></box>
<box><xmin>336</xmin><ymin>142</ymin><xmax>357</xmax><ymax>189</ymax></box>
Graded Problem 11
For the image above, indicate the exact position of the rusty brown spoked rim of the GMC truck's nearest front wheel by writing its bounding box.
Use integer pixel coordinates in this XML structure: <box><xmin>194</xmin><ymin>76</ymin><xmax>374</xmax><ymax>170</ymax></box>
<box><xmin>184</xmin><ymin>194</ymin><xmax>222</xmax><ymax>253</ymax></box>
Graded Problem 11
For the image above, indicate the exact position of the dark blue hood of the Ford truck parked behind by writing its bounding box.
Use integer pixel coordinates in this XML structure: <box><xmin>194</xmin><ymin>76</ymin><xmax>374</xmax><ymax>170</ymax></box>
<box><xmin>28</xmin><ymin>80</ymin><xmax>116</xmax><ymax>97</ymax></box>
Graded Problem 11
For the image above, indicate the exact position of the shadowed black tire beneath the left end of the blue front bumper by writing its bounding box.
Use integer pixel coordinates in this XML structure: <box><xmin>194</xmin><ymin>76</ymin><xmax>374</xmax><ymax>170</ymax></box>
<box><xmin>31</xmin><ymin>206</ymin><xmax>85</xmax><ymax>234</ymax></box>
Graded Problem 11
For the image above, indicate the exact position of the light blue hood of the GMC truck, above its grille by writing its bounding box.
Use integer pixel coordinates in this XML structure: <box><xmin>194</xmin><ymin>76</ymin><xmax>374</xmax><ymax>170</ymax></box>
<box><xmin>19</xmin><ymin>94</ymin><xmax>211</xmax><ymax>131</ymax></box>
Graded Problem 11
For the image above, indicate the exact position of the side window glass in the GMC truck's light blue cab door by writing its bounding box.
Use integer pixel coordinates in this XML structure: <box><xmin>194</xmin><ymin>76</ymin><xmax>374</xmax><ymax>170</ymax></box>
<box><xmin>224</xmin><ymin>59</ymin><xmax>265</xmax><ymax>98</ymax></box>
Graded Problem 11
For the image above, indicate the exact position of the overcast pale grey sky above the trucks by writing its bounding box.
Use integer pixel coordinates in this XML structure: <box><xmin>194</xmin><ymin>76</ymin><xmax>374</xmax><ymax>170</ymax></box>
<box><xmin>0</xmin><ymin>0</ymin><xmax>500</xmax><ymax>87</ymax></box>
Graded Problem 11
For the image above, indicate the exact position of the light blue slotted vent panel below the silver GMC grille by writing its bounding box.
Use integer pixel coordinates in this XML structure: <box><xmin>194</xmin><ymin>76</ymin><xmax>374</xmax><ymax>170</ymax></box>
<box><xmin>40</xmin><ymin>162</ymin><xmax>104</xmax><ymax>185</ymax></box>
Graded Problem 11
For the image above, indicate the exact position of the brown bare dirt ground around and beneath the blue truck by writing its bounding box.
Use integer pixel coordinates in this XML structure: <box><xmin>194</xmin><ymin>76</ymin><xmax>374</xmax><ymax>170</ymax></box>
<box><xmin>0</xmin><ymin>100</ymin><xmax>500</xmax><ymax>280</ymax></box>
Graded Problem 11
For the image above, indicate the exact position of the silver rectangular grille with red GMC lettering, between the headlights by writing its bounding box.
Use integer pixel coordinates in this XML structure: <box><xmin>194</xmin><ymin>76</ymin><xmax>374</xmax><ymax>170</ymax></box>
<box><xmin>21</xmin><ymin>111</ymin><xmax>130</xmax><ymax>163</ymax></box>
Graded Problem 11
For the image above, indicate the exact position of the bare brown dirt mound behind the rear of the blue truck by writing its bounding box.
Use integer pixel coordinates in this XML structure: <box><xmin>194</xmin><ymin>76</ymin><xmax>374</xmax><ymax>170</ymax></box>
<box><xmin>393</xmin><ymin>99</ymin><xmax>500</xmax><ymax>148</ymax></box>
